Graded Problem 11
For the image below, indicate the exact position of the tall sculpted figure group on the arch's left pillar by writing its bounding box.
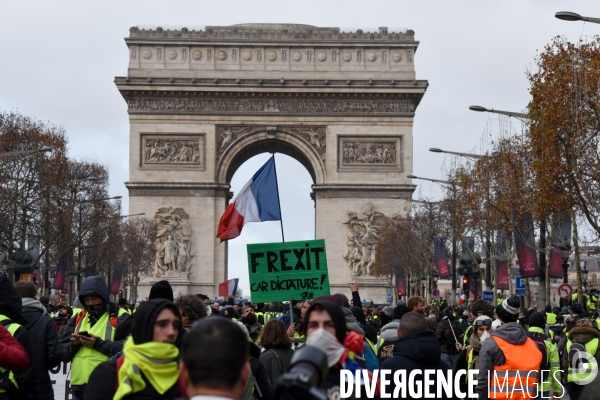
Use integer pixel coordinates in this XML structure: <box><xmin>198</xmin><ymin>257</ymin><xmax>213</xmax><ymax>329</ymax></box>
<box><xmin>151</xmin><ymin>206</ymin><xmax>194</xmax><ymax>277</ymax></box>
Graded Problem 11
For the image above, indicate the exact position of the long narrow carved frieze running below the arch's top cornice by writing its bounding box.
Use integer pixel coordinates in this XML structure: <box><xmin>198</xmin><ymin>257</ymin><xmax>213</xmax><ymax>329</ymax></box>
<box><xmin>127</xmin><ymin>97</ymin><xmax>415</xmax><ymax>114</ymax></box>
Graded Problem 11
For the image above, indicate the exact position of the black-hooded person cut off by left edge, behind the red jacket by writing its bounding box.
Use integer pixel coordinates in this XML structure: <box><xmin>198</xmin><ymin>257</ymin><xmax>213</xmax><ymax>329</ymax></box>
<box><xmin>0</xmin><ymin>275</ymin><xmax>37</xmax><ymax>400</ymax></box>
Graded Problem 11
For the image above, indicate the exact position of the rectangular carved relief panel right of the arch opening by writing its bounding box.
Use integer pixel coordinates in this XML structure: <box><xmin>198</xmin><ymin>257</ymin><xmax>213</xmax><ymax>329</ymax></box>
<box><xmin>338</xmin><ymin>136</ymin><xmax>402</xmax><ymax>171</ymax></box>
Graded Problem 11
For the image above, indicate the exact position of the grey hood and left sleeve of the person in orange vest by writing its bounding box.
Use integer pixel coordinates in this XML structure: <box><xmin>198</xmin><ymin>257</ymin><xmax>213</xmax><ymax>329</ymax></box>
<box><xmin>477</xmin><ymin>322</ymin><xmax>528</xmax><ymax>399</ymax></box>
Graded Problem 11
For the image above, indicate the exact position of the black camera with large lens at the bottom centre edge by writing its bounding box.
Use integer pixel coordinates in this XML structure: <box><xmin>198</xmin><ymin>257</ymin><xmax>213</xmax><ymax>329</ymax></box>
<box><xmin>271</xmin><ymin>346</ymin><xmax>329</xmax><ymax>400</ymax></box>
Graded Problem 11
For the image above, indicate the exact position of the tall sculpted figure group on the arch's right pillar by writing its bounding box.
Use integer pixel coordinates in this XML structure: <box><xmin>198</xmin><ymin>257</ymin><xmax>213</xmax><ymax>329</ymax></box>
<box><xmin>342</xmin><ymin>203</ymin><xmax>388</xmax><ymax>276</ymax></box>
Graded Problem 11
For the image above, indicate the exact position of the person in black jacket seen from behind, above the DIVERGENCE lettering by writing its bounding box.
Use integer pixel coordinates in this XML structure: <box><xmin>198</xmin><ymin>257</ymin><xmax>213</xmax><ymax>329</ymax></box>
<box><xmin>381</xmin><ymin>312</ymin><xmax>452</xmax><ymax>399</ymax></box>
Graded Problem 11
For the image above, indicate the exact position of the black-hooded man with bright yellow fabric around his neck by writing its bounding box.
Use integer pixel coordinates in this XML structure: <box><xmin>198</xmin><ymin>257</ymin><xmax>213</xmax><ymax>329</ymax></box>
<box><xmin>85</xmin><ymin>299</ymin><xmax>183</xmax><ymax>400</ymax></box>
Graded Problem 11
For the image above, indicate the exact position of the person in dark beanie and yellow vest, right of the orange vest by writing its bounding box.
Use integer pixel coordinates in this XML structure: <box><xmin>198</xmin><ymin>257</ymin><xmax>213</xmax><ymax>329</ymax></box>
<box><xmin>527</xmin><ymin>311</ymin><xmax>563</xmax><ymax>398</ymax></box>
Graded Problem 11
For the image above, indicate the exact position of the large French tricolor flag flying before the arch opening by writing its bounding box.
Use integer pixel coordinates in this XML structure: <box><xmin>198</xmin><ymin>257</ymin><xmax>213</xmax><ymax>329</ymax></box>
<box><xmin>217</xmin><ymin>156</ymin><xmax>281</xmax><ymax>242</ymax></box>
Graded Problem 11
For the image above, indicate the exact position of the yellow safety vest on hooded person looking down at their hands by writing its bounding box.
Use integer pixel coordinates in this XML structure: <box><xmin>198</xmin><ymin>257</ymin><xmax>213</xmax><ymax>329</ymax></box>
<box><xmin>71</xmin><ymin>311</ymin><xmax>114</xmax><ymax>385</ymax></box>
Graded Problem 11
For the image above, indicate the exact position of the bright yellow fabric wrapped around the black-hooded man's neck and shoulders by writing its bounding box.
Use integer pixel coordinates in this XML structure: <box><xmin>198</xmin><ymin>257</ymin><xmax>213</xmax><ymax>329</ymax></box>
<box><xmin>113</xmin><ymin>336</ymin><xmax>179</xmax><ymax>400</ymax></box>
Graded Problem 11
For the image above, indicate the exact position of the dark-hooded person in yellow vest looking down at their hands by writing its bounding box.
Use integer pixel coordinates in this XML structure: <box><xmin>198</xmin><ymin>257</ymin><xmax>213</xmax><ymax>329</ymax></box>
<box><xmin>58</xmin><ymin>276</ymin><xmax>129</xmax><ymax>400</ymax></box>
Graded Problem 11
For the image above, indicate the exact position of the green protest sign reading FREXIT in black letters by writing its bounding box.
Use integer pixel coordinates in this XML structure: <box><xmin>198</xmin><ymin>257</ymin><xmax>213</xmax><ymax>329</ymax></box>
<box><xmin>247</xmin><ymin>239</ymin><xmax>329</xmax><ymax>303</ymax></box>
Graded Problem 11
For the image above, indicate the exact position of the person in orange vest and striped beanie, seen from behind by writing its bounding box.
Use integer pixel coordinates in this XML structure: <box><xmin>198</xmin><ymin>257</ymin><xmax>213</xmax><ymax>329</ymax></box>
<box><xmin>477</xmin><ymin>295</ymin><xmax>542</xmax><ymax>399</ymax></box>
